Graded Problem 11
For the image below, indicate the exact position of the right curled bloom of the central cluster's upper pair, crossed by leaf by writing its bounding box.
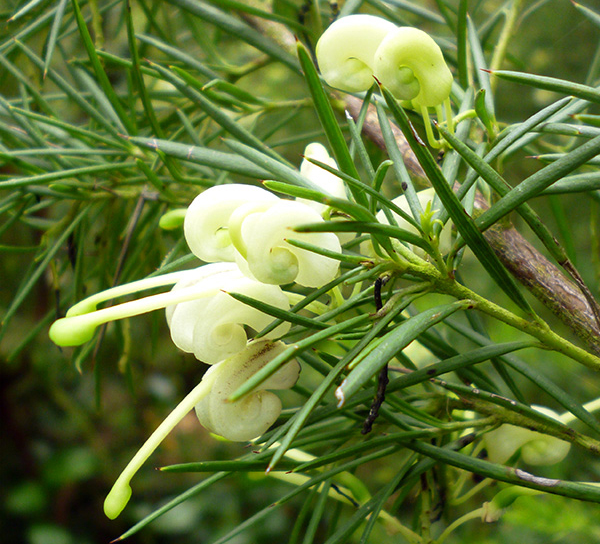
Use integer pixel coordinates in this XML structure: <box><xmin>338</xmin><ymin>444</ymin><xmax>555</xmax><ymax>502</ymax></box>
<box><xmin>232</xmin><ymin>200</ymin><xmax>341</xmax><ymax>287</ymax></box>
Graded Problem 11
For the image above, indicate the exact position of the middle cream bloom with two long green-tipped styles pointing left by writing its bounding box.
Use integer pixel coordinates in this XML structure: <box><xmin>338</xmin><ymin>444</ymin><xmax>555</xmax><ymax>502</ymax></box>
<box><xmin>50</xmin><ymin>263</ymin><xmax>290</xmax><ymax>364</ymax></box>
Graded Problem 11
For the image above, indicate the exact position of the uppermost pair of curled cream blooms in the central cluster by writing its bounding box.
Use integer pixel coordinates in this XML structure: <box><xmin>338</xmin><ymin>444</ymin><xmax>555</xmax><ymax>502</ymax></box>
<box><xmin>184</xmin><ymin>184</ymin><xmax>341</xmax><ymax>287</ymax></box>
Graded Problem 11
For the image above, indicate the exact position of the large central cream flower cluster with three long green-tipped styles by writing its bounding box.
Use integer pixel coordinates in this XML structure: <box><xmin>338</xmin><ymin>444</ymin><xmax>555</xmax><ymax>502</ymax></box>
<box><xmin>50</xmin><ymin>144</ymin><xmax>346</xmax><ymax>518</ymax></box>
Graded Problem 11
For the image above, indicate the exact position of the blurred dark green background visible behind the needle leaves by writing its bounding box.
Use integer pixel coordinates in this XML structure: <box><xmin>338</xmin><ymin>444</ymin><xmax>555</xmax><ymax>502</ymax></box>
<box><xmin>0</xmin><ymin>0</ymin><xmax>600</xmax><ymax>544</ymax></box>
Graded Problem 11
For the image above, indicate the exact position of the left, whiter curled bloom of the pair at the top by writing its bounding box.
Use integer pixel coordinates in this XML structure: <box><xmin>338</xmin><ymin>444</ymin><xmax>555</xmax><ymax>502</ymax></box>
<box><xmin>316</xmin><ymin>15</ymin><xmax>397</xmax><ymax>92</ymax></box>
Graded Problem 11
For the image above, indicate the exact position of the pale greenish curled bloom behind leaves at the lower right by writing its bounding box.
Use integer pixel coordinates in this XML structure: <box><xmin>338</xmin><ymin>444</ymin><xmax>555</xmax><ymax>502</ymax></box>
<box><xmin>484</xmin><ymin>406</ymin><xmax>571</xmax><ymax>466</ymax></box>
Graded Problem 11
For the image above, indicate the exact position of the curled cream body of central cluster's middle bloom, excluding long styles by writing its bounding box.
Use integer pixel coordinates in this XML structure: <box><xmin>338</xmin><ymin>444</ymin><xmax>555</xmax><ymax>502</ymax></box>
<box><xmin>167</xmin><ymin>263</ymin><xmax>290</xmax><ymax>364</ymax></box>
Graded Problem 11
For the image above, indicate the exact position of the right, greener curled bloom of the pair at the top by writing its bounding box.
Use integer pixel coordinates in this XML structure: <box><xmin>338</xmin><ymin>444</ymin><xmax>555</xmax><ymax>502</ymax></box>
<box><xmin>373</xmin><ymin>27</ymin><xmax>452</xmax><ymax>107</ymax></box>
